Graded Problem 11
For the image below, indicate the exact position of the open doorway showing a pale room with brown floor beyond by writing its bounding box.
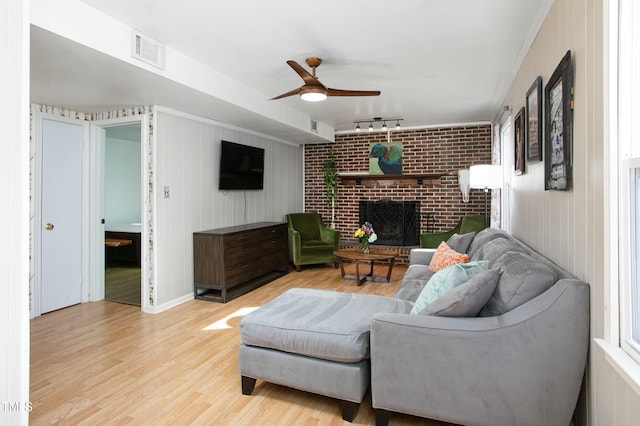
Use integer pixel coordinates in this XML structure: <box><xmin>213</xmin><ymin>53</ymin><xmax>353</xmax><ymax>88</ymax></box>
<box><xmin>103</xmin><ymin>122</ymin><xmax>142</xmax><ymax>306</ymax></box>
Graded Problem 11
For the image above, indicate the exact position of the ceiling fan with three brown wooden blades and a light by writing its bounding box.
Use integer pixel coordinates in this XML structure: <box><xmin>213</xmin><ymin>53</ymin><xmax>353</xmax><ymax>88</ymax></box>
<box><xmin>270</xmin><ymin>58</ymin><xmax>380</xmax><ymax>102</ymax></box>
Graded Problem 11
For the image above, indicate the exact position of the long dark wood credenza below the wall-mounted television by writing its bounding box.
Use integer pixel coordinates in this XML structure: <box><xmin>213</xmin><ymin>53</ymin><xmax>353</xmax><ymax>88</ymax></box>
<box><xmin>193</xmin><ymin>222</ymin><xmax>289</xmax><ymax>303</ymax></box>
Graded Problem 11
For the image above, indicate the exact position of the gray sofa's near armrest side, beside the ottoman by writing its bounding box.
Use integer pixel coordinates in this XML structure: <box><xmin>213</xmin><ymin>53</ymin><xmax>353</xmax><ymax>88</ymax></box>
<box><xmin>371</xmin><ymin>280</ymin><xmax>589</xmax><ymax>426</ymax></box>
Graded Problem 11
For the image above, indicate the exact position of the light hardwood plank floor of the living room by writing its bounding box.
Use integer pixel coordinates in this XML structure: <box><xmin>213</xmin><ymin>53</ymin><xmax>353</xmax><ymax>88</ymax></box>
<box><xmin>30</xmin><ymin>266</ymin><xmax>450</xmax><ymax>425</ymax></box>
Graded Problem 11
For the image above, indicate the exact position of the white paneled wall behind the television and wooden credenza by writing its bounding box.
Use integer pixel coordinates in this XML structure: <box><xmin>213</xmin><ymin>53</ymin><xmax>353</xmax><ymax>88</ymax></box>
<box><xmin>153</xmin><ymin>108</ymin><xmax>303</xmax><ymax>309</ymax></box>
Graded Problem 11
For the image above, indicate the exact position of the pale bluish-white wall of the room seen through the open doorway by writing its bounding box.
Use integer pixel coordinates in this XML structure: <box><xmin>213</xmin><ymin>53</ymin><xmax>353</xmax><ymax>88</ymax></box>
<box><xmin>104</xmin><ymin>133</ymin><xmax>142</xmax><ymax>227</ymax></box>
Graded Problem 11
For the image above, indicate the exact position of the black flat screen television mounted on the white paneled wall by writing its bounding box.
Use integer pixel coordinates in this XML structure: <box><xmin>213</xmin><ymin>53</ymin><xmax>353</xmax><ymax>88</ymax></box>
<box><xmin>218</xmin><ymin>140</ymin><xmax>264</xmax><ymax>190</ymax></box>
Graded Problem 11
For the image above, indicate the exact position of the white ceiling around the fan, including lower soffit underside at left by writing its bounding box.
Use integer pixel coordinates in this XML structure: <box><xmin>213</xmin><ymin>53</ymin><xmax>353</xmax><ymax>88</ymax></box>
<box><xmin>31</xmin><ymin>0</ymin><xmax>553</xmax><ymax>143</ymax></box>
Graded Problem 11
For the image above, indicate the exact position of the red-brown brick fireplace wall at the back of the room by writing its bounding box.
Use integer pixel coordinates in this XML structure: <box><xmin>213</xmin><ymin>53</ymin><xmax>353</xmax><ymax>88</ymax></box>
<box><xmin>304</xmin><ymin>124</ymin><xmax>491</xmax><ymax>264</ymax></box>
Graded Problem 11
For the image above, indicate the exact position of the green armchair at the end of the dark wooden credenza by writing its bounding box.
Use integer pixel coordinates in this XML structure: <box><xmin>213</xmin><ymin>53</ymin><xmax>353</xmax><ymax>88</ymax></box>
<box><xmin>287</xmin><ymin>213</ymin><xmax>340</xmax><ymax>272</ymax></box>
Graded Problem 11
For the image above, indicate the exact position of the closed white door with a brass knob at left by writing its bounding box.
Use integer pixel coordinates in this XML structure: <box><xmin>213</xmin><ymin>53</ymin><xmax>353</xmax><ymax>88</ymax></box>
<box><xmin>40</xmin><ymin>118</ymin><xmax>85</xmax><ymax>313</ymax></box>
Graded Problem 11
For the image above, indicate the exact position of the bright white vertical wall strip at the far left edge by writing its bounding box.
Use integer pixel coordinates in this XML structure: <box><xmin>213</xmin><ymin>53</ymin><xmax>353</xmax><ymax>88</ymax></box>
<box><xmin>0</xmin><ymin>0</ymin><xmax>29</xmax><ymax>425</ymax></box>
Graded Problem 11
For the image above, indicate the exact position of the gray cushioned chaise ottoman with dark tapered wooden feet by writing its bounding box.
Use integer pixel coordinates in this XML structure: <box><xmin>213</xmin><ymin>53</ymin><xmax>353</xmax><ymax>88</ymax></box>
<box><xmin>239</xmin><ymin>288</ymin><xmax>412</xmax><ymax>421</ymax></box>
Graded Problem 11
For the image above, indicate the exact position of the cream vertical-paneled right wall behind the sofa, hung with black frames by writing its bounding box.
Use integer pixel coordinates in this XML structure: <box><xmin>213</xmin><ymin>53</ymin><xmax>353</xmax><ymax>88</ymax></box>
<box><xmin>503</xmin><ymin>0</ymin><xmax>640</xmax><ymax>425</ymax></box>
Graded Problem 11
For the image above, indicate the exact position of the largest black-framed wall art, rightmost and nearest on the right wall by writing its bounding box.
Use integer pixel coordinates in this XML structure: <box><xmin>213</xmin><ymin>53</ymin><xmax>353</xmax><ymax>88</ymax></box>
<box><xmin>544</xmin><ymin>51</ymin><xmax>573</xmax><ymax>191</ymax></box>
